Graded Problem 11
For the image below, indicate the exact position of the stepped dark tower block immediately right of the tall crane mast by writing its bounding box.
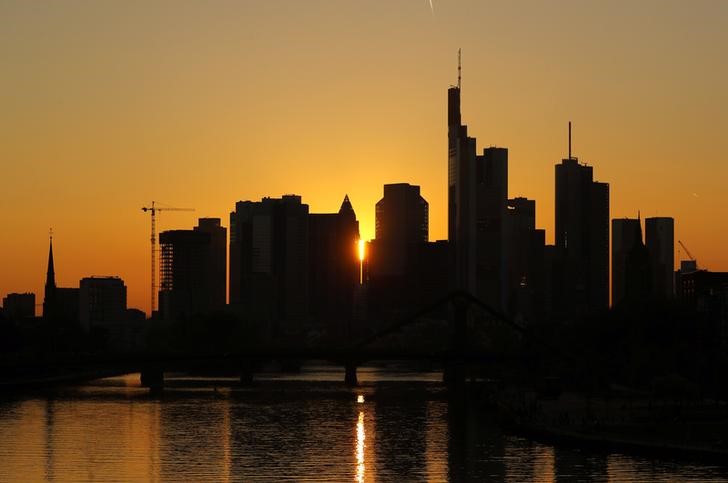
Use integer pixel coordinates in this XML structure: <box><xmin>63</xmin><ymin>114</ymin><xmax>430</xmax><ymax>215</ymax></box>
<box><xmin>159</xmin><ymin>218</ymin><xmax>227</xmax><ymax>320</ymax></box>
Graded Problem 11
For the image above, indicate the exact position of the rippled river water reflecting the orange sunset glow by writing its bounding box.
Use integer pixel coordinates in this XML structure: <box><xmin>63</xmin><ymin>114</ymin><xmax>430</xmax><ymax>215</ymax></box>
<box><xmin>0</xmin><ymin>369</ymin><xmax>728</xmax><ymax>482</ymax></box>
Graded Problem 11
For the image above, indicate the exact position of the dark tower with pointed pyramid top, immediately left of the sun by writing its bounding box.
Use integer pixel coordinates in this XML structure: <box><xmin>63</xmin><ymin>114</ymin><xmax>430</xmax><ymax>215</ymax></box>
<box><xmin>308</xmin><ymin>196</ymin><xmax>360</xmax><ymax>336</ymax></box>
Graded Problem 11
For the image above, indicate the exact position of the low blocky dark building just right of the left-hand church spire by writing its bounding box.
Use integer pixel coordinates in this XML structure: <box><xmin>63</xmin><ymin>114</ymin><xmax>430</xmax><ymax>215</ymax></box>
<box><xmin>78</xmin><ymin>277</ymin><xmax>126</xmax><ymax>331</ymax></box>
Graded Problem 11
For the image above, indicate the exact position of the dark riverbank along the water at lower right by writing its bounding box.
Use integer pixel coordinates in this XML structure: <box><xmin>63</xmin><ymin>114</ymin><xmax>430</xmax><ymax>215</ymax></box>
<box><xmin>497</xmin><ymin>393</ymin><xmax>728</xmax><ymax>465</ymax></box>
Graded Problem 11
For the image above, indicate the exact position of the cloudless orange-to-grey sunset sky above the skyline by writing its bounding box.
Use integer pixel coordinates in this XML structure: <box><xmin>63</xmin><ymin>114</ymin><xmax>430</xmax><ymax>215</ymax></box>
<box><xmin>0</xmin><ymin>0</ymin><xmax>728</xmax><ymax>316</ymax></box>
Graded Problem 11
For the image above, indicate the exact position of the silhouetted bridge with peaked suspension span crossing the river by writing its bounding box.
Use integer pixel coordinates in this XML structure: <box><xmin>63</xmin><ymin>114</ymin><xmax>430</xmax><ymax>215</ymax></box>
<box><xmin>0</xmin><ymin>292</ymin><xmax>527</xmax><ymax>390</ymax></box>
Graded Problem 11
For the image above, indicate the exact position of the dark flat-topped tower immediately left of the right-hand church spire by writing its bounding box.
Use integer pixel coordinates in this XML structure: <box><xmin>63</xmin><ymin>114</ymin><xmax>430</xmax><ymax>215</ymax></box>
<box><xmin>612</xmin><ymin>218</ymin><xmax>642</xmax><ymax>307</ymax></box>
